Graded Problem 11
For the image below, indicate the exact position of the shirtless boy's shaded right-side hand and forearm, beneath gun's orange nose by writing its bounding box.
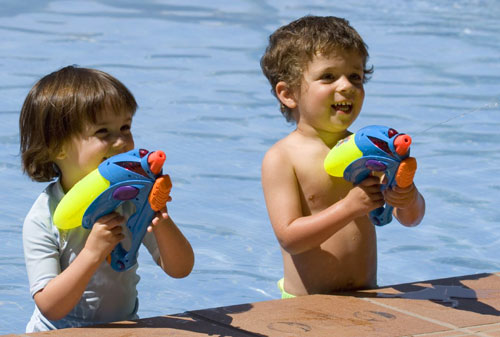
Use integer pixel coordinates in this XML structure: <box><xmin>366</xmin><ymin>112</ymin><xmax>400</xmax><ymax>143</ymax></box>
<box><xmin>384</xmin><ymin>184</ymin><xmax>425</xmax><ymax>227</ymax></box>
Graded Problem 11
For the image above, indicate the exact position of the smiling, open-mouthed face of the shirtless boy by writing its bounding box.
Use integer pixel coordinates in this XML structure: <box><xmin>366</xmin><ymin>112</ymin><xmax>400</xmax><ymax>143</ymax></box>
<box><xmin>296</xmin><ymin>50</ymin><xmax>365</xmax><ymax>133</ymax></box>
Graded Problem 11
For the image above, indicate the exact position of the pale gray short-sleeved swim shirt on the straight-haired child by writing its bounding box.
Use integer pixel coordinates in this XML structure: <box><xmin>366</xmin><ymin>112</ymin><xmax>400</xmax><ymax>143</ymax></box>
<box><xmin>23</xmin><ymin>181</ymin><xmax>160</xmax><ymax>332</ymax></box>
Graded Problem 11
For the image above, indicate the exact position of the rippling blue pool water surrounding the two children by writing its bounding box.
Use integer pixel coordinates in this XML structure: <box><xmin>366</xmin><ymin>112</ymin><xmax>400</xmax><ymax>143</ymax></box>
<box><xmin>0</xmin><ymin>0</ymin><xmax>500</xmax><ymax>334</ymax></box>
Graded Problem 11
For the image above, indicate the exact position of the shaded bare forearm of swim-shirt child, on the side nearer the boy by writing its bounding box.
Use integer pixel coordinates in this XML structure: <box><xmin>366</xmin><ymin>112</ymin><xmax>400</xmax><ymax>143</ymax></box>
<box><xmin>148</xmin><ymin>207</ymin><xmax>194</xmax><ymax>278</ymax></box>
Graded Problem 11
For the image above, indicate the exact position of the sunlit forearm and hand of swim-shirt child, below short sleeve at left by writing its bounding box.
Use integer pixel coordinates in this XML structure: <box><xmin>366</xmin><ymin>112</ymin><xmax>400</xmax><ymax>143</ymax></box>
<box><xmin>34</xmin><ymin>213</ymin><xmax>124</xmax><ymax>320</ymax></box>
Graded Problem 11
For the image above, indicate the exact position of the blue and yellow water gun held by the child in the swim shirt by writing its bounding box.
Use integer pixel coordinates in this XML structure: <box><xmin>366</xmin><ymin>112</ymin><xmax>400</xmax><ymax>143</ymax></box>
<box><xmin>53</xmin><ymin>149</ymin><xmax>172</xmax><ymax>271</ymax></box>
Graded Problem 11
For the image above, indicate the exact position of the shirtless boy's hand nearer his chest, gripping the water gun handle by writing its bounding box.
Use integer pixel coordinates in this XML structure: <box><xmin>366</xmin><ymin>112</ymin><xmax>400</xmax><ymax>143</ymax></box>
<box><xmin>346</xmin><ymin>176</ymin><xmax>385</xmax><ymax>216</ymax></box>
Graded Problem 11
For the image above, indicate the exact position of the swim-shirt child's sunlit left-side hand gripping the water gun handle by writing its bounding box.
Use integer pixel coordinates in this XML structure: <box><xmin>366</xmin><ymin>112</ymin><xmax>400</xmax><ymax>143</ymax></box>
<box><xmin>84</xmin><ymin>212</ymin><xmax>125</xmax><ymax>261</ymax></box>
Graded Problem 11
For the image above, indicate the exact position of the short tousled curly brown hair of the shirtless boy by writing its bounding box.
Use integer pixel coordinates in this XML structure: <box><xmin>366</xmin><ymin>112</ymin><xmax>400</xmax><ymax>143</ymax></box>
<box><xmin>260</xmin><ymin>15</ymin><xmax>373</xmax><ymax>121</ymax></box>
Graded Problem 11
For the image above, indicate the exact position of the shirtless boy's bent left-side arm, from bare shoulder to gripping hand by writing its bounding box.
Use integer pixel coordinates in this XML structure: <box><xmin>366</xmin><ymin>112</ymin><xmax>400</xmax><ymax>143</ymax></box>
<box><xmin>262</xmin><ymin>148</ymin><xmax>384</xmax><ymax>254</ymax></box>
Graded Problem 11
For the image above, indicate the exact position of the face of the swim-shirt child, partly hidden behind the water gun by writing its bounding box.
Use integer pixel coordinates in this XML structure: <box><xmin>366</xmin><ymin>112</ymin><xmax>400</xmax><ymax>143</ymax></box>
<box><xmin>55</xmin><ymin>111</ymin><xmax>134</xmax><ymax>191</ymax></box>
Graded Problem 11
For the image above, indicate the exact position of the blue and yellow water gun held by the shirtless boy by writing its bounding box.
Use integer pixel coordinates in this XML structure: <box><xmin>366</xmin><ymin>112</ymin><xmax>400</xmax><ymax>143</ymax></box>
<box><xmin>324</xmin><ymin>125</ymin><xmax>417</xmax><ymax>226</ymax></box>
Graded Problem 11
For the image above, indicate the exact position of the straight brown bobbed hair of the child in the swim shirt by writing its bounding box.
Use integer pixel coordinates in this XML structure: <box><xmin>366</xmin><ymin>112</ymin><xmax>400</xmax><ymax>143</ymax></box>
<box><xmin>19</xmin><ymin>66</ymin><xmax>137</xmax><ymax>181</ymax></box>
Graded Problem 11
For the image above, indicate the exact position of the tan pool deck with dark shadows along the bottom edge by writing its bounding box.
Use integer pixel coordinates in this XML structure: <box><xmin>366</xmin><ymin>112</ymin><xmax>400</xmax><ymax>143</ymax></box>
<box><xmin>6</xmin><ymin>272</ymin><xmax>500</xmax><ymax>337</ymax></box>
